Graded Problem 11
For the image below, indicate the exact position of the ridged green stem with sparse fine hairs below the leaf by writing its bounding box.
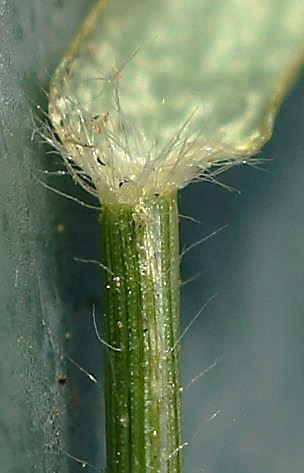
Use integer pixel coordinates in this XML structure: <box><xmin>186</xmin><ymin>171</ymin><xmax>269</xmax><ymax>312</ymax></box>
<box><xmin>102</xmin><ymin>193</ymin><xmax>182</xmax><ymax>473</ymax></box>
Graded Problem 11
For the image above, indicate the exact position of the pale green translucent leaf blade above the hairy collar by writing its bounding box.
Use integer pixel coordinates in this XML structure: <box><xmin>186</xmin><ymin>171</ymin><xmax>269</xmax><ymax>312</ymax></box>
<box><xmin>50</xmin><ymin>0</ymin><xmax>304</xmax><ymax>195</ymax></box>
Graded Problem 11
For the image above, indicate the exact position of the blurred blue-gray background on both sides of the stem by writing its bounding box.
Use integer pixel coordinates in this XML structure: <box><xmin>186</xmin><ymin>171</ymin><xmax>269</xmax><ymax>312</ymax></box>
<box><xmin>0</xmin><ymin>0</ymin><xmax>304</xmax><ymax>473</ymax></box>
